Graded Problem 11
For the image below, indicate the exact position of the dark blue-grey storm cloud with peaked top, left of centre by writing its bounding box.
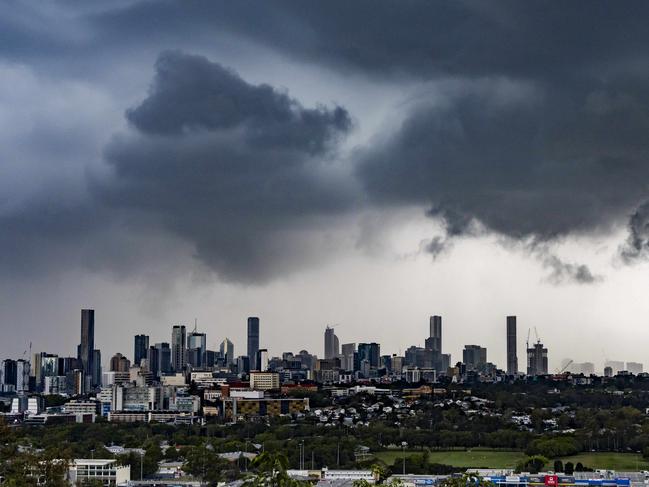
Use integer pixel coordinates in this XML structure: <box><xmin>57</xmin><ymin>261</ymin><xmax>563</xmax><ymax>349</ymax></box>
<box><xmin>96</xmin><ymin>52</ymin><xmax>353</xmax><ymax>281</ymax></box>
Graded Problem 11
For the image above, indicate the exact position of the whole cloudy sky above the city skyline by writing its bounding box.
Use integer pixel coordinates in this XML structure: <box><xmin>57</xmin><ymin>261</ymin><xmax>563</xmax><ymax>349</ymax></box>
<box><xmin>0</xmin><ymin>0</ymin><xmax>649</xmax><ymax>369</ymax></box>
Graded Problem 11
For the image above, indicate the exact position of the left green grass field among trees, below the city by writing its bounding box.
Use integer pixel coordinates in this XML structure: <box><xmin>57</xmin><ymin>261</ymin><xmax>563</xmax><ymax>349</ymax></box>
<box><xmin>375</xmin><ymin>450</ymin><xmax>525</xmax><ymax>468</ymax></box>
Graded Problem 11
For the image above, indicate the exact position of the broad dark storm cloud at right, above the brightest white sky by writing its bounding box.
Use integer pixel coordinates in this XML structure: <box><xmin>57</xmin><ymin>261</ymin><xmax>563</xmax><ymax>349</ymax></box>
<box><xmin>359</xmin><ymin>80</ymin><xmax>649</xmax><ymax>240</ymax></box>
